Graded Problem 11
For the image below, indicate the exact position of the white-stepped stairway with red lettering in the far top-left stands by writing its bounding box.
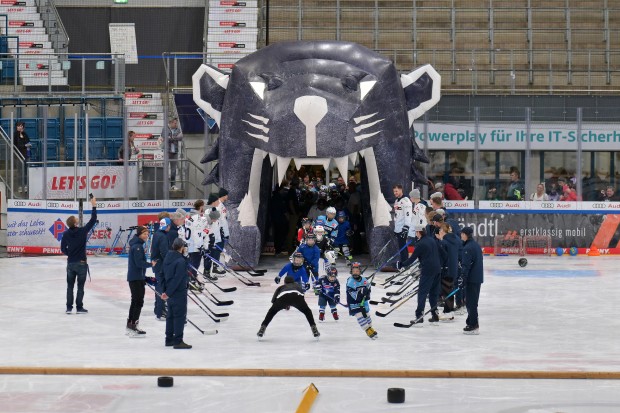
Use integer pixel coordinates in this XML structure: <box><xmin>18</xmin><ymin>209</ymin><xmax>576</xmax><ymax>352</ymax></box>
<box><xmin>0</xmin><ymin>0</ymin><xmax>67</xmax><ymax>86</ymax></box>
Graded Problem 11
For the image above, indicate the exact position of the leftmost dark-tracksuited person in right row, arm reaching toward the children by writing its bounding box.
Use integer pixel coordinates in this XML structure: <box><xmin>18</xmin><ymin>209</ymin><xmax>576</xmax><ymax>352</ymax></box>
<box><xmin>400</xmin><ymin>225</ymin><xmax>441</xmax><ymax>324</ymax></box>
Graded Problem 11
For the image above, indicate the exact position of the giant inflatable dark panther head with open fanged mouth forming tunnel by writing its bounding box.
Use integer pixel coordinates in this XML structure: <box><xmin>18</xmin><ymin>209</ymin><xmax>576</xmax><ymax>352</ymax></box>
<box><xmin>193</xmin><ymin>41</ymin><xmax>441</xmax><ymax>262</ymax></box>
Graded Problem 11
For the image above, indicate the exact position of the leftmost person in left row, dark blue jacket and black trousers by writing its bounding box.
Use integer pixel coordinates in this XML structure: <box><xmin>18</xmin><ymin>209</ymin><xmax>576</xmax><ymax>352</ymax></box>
<box><xmin>126</xmin><ymin>226</ymin><xmax>157</xmax><ymax>337</ymax></box>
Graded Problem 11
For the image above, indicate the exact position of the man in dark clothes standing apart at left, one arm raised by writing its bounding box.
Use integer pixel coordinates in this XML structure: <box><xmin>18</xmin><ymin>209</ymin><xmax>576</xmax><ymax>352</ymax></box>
<box><xmin>60</xmin><ymin>198</ymin><xmax>97</xmax><ymax>314</ymax></box>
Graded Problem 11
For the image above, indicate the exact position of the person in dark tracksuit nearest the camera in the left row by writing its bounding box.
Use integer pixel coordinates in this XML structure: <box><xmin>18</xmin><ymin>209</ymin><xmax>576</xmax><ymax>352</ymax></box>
<box><xmin>161</xmin><ymin>238</ymin><xmax>192</xmax><ymax>349</ymax></box>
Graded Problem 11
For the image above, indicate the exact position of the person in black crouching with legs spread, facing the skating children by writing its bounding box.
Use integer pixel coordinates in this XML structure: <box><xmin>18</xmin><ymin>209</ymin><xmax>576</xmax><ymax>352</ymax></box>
<box><xmin>256</xmin><ymin>275</ymin><xmax>320</xmax><ymax>339</ymax></box>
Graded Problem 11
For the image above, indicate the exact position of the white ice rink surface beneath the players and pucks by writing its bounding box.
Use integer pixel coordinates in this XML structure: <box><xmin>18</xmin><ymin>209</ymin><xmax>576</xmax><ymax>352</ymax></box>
<box><xmin>0</xmin><ymin>251</ymin><xmax>620</xmax><ymax>413</ymax></box>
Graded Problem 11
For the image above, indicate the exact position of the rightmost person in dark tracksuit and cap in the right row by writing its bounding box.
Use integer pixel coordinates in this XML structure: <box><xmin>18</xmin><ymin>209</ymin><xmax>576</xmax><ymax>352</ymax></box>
<box><xmin>461</xmin><ymin>227</ymin><xmax>484</xmax><ymax>334</ymax></box>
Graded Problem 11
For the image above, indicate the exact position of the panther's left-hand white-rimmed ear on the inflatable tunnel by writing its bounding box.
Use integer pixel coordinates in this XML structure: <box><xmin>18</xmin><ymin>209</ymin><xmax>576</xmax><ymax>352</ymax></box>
<box><xmin>192</xmin><ymin>64</ymin><xmax>229</xmax><ymax>126</ymax></box>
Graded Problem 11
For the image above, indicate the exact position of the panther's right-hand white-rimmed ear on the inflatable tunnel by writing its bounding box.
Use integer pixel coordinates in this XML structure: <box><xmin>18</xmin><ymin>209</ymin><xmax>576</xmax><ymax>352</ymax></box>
<box><xmin>400</xmin><ymin>65</ymin><xmax>441</xmax><ymax>127</ymax></box>
